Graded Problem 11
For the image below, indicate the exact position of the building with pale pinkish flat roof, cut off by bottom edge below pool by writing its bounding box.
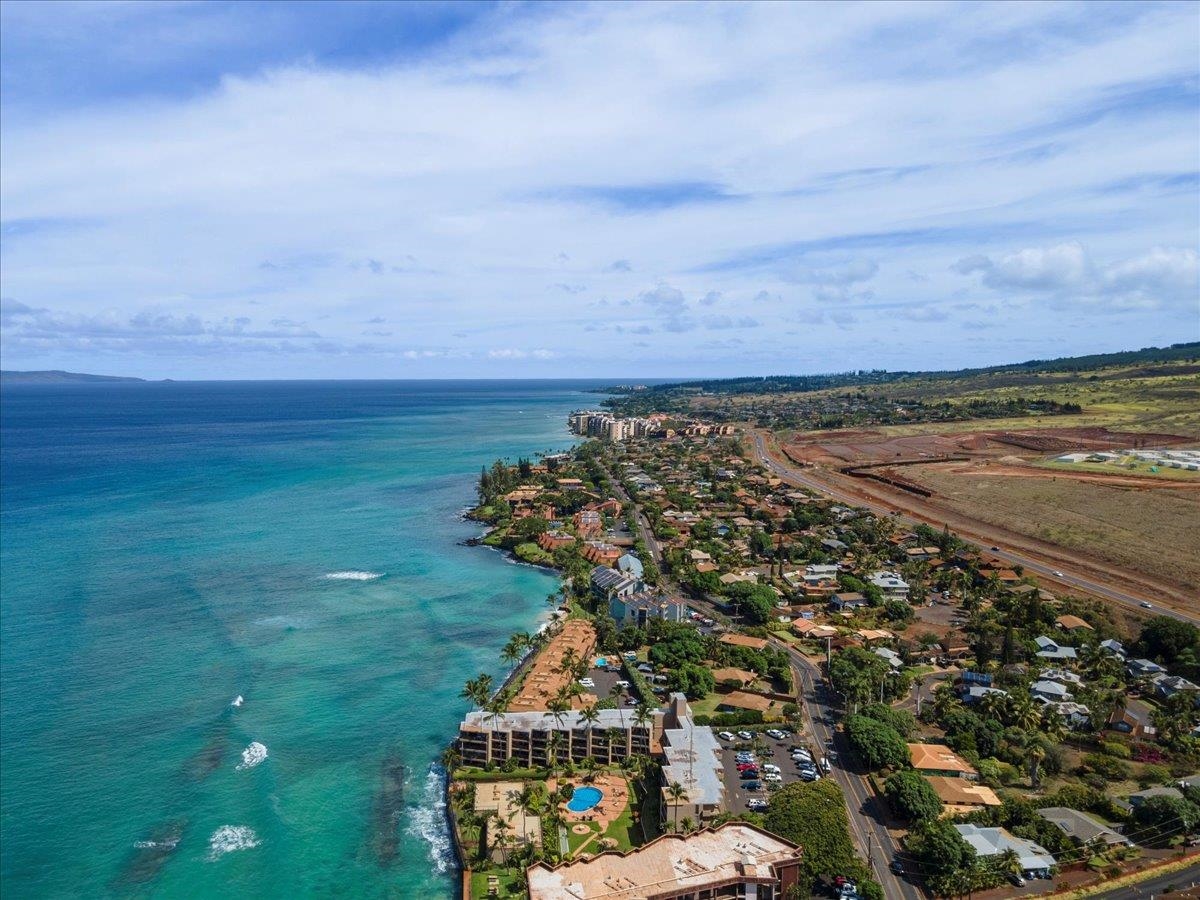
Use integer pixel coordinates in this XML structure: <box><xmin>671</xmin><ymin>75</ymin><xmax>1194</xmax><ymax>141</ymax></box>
<box><xmin>526</xmin><ymin>822</ymin><xmax>803</xmax><ymax>900</ymax></box>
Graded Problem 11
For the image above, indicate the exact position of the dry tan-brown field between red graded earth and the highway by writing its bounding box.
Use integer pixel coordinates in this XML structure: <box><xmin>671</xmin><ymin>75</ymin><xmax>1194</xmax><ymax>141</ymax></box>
<box><xmin>906</xmin><ymin>466</ymin><xmax>1200</xmax><ymax>596</ymax></box>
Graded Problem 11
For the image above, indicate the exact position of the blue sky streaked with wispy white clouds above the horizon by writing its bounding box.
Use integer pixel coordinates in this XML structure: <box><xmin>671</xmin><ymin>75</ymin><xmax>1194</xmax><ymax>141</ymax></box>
<box><xmin>0</xmin><ymin>0</ymin><xmax>1200</xmax><ymax>378</ymax></box>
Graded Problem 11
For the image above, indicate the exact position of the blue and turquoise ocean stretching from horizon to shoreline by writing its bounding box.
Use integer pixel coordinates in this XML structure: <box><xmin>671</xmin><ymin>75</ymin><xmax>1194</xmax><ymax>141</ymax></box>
<box><xmin>0</xmin><ymin>382</ymin><xmax>595</xmax><ymax>898</ymax></box>
